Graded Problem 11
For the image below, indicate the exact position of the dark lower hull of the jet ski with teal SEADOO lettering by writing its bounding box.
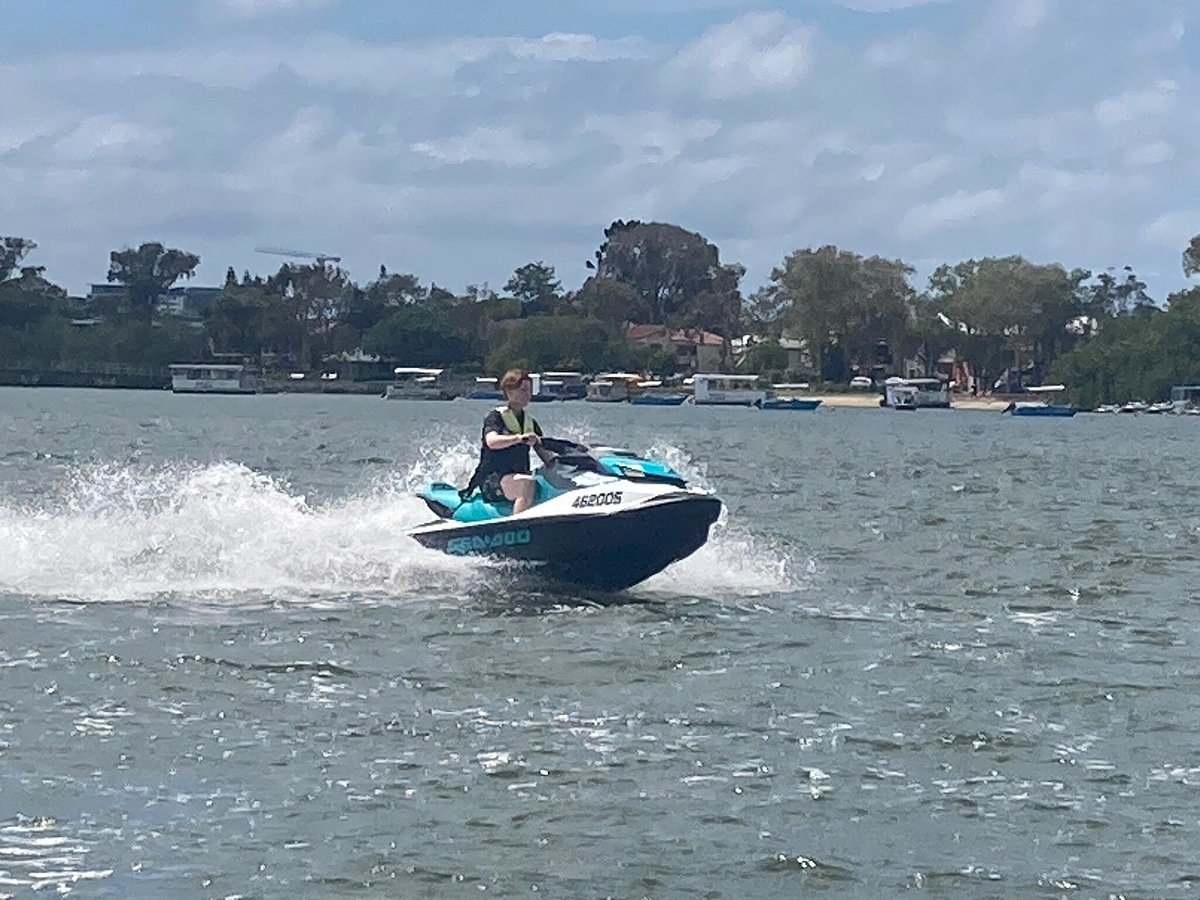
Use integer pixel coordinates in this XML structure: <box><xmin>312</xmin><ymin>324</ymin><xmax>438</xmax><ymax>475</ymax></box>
<box><xmin>412</xmin><ymin>491</ymin><xmax>721</xmax><ymax>590</ymax></box>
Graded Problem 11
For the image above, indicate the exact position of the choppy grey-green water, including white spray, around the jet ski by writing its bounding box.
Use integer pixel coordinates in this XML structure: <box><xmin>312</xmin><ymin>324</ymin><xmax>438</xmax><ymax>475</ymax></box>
<box><xmin>0</xmin><ymin>389</ymin><xmax>1200</xmax><ymax>898</ymax></box>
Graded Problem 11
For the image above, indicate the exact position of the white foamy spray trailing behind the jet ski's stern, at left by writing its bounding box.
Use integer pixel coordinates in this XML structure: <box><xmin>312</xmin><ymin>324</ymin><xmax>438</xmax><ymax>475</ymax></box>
<box><xmin>0</xmin><ymin>463</ymin><xmax>470</xmax><ymax>600</ymax></box>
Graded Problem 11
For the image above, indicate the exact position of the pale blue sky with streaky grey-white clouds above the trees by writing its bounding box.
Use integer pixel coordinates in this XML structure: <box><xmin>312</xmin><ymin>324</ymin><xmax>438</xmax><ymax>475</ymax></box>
<box><xmin>0</xmin><ymin>0</ymin><xmax>1200</xmax><ymax>300</ymax></box>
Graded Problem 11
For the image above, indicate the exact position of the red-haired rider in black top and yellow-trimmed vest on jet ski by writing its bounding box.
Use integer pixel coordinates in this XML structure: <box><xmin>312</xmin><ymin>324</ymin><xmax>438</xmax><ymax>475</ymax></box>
<box><xmin>462</xmin><ymin>368</ymin><xmax>554</xmax><ymax>514</ymax></box>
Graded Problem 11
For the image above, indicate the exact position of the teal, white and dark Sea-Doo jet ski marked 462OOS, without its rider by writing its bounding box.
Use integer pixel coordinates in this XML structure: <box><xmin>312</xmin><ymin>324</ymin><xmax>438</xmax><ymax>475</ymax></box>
<box><xmin>409</xmin><ymin>438</ymin><xmax>721</xmax><ymax>590</ymax></box>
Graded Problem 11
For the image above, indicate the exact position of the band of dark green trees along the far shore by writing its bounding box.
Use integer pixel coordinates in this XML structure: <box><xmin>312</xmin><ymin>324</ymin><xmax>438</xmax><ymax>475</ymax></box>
<box><xmin>0</xmin><ymin>226</ymin><xmax>1200</xmax><ymax>404</ymax></box>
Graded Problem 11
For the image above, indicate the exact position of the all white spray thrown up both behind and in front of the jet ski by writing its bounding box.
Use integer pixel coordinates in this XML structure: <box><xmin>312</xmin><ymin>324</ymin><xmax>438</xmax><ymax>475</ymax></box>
<box><xmin>0</xmin><ymin>440</ymin><xmax>796</xmax><ymax>602</ymax></box>
